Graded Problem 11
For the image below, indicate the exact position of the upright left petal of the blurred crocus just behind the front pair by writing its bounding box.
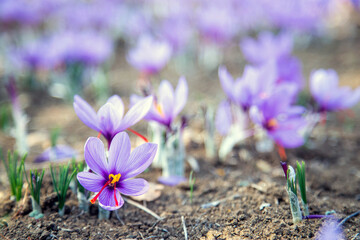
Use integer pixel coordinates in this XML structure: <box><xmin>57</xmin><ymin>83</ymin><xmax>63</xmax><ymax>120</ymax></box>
<box><xmin>158</xmin><ymin>80</ymin><xmax>175</xmax><ymax>122</ymax></box>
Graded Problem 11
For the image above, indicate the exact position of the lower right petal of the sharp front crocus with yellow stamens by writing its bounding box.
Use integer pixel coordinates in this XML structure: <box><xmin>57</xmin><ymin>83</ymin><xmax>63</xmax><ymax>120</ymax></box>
<box><xmin>119</xmin><ymin>178</ymin><xmax>149</xmax><ymax>196</ymax></box>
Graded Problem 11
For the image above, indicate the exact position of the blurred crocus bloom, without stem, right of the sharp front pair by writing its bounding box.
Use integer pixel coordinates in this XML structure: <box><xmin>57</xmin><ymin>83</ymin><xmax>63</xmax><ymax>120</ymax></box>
<box><xmin>130</xmin><ymin>77</ymin><xmax>188</xmax><ymax>128</ymax></box>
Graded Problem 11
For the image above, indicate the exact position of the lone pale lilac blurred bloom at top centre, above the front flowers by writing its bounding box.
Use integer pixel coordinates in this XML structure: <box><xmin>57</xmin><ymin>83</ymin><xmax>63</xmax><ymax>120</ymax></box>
<box><xmin>126</xmin><ymin>35</ymin><xmax>172</xmax><ymax>74</ymax></box>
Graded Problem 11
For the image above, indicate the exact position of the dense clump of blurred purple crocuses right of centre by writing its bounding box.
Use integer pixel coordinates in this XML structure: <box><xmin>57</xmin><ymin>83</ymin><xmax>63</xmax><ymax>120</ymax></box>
<box><xmin>216</xmin><ymin>32</ymin><xmax>306</xmax><ymax>157</ymax></box>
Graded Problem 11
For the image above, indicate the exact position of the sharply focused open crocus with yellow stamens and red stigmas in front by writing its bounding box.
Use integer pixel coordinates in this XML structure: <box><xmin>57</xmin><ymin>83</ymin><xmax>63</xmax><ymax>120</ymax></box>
<box><xmin>77</xmin><ymin>132</ymin><xmax>157</xmax><ymax>211</ymax></box>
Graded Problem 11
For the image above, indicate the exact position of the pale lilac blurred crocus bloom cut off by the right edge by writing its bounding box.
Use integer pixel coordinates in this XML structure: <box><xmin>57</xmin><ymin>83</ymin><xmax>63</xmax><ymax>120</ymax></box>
<box><xmin>310</xmin><ymin>69</ymin><xmax>360</xmax><ymax>112</ymax></box>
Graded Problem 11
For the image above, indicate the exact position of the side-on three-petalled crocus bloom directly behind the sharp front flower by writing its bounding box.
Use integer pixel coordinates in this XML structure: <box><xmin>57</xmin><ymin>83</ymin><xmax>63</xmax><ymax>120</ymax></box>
<box><xmin>74</xmin><ymin>95</ymin><xmax>153</xmax><ymax>146</ymax></box>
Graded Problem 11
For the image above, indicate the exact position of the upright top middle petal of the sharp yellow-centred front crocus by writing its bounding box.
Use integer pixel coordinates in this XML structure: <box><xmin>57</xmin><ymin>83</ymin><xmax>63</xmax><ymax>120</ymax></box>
<box><xmin>109</xmin><ymin>132</ymin><xmax>131</xmax><ymax>174</ymax></box>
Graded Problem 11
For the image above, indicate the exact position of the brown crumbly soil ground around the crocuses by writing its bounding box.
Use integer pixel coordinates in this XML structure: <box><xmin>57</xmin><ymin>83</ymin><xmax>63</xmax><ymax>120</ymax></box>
<box><xmin>0</xmin><ymin>36</ymin><xmax>360</xmax><ymax>239</ymax></box>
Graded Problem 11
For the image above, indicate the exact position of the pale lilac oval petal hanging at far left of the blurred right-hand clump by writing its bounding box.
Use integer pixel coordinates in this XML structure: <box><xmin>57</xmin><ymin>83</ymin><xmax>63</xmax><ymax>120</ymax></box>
<box><xmin>215</xmin><ymin>100</ymin><xmax>232</xmax><ymax>136</ymax></box>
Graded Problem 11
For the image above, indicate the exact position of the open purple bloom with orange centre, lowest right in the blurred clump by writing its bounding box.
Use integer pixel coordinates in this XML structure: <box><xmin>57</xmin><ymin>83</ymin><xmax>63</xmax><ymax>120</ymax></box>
<box><xmin>249</xmin><ymin>85</ymin><xmax>307</xmax><ymax>148</ymax></box>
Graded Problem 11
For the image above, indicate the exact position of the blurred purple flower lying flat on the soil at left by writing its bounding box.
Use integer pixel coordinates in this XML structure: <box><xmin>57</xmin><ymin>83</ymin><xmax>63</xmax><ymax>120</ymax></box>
<box><xmin>34</xmin><ymin>145</ymin><xmax>77</xmax><ymax>163</ymax></box>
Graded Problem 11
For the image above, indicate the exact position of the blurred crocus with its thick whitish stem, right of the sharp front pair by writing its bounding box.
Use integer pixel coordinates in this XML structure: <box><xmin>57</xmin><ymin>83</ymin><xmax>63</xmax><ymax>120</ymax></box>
<box><xmin>131</xmin><ymin>77</ymin><xmax>188</xmax><ymax>185</ymax></box>
